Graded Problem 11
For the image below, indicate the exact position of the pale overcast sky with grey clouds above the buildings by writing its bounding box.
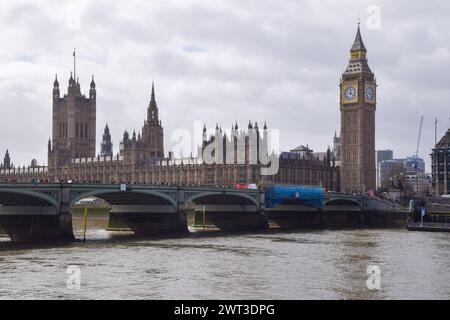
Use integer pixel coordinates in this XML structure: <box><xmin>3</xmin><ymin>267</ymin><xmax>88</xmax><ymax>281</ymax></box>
<box><xmin>0</xmin><ymin>0</ymin><xmax>450</xmax><ymax>170</ymax></box>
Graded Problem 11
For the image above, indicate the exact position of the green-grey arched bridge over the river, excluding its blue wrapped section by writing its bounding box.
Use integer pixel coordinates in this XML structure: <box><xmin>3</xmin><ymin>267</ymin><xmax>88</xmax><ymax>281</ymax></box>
<box><xmin>0</xmin><ymin>183</ymin><xmax>406</xmax><ymax>240</ymax></box>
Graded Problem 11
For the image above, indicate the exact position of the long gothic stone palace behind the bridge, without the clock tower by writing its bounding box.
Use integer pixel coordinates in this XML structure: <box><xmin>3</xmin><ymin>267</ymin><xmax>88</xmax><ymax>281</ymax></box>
<box><xmin>0</xmin><ymin>66</ymin><xmax>340</xmax><ymax>191</ymax></box>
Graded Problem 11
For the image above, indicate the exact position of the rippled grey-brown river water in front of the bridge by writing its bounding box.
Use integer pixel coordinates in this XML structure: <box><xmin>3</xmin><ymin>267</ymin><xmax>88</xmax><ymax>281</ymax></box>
<box><xmin>0</xmin><ymin>215</ymin><xmax>450</xmax><ymax>300</ymax></box>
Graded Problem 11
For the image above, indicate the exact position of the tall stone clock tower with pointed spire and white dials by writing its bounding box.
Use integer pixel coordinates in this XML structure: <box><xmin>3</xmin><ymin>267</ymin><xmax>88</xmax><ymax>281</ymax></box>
<box><xmin>340</xmin><ymin>23</ymin><xmax>377</xmax><ymax>193</ymax></box>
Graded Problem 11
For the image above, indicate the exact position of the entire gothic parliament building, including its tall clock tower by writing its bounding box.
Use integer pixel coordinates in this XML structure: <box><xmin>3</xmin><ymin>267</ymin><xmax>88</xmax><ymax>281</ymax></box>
<box><xmin>0</xmin><ymin>26</ymin><xmax>376</xmax><ymax>192</ymax></box>
